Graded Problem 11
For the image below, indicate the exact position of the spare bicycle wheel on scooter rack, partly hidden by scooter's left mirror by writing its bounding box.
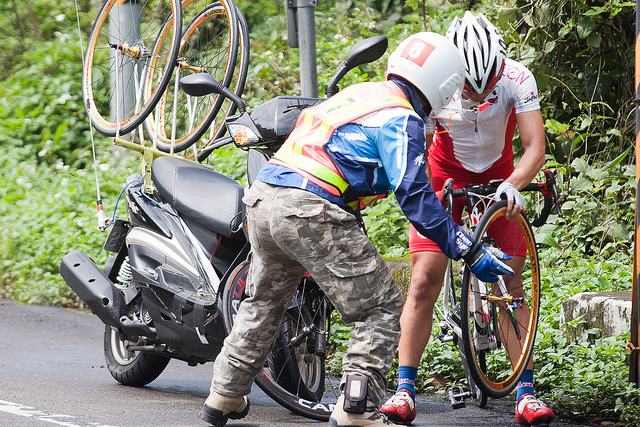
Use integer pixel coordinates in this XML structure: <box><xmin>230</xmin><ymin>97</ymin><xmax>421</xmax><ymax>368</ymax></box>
<box><xmin>145</xmin><ymin>0</ymin><xmax>239</xmax><ymax>152</ymax></box>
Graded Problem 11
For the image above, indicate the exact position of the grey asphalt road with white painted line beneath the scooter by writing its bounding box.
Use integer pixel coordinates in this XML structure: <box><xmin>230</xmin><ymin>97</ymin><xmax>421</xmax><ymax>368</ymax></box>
<box><xmin>0</xmin><ymin>299</ymin><xmax>594</xmax><ymax>427</ymax></box>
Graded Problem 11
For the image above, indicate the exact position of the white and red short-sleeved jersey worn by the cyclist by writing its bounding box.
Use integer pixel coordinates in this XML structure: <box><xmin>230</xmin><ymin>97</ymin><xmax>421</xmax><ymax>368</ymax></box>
<box><xmin>427</xmin><ymin>59</ymin><xmax>540</xmax><ymax>173</ymax></box>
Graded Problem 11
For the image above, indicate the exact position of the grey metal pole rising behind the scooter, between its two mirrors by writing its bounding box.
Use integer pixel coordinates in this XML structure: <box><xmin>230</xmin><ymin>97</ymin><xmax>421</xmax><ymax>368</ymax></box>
<box><xmin>285</xmin><ymin>0</ymin><xmax>318</xmax><ymax>98</ymax></box>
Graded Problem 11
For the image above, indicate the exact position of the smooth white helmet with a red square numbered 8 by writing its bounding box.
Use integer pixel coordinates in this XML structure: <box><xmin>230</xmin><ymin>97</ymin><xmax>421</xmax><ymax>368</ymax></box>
<box><xmin>387</xmin><ymin>32</ymin><xmax>464</xmax><ymax>113</ymax></box>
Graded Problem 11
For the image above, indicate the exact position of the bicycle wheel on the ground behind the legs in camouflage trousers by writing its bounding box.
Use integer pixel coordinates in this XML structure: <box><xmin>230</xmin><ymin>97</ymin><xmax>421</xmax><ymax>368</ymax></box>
<box><xmin>222</xmin><ymin>261</ymin><xmax>340</xmax><ymax>421</ymax></box>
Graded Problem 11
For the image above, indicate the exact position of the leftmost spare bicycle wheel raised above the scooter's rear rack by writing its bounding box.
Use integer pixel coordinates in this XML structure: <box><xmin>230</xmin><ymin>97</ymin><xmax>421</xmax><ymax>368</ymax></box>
<box><xmin>82</xmin><ymin>0</ymin><xmax>182</xmax><ymax>137</ymax></box>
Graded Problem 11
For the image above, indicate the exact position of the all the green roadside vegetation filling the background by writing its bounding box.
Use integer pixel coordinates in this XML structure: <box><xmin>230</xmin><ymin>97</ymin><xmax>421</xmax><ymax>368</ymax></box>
<box><xmin>0</xmin><ymin>0</ymin><xmax>640</xmax><ymax>425</ymax></box>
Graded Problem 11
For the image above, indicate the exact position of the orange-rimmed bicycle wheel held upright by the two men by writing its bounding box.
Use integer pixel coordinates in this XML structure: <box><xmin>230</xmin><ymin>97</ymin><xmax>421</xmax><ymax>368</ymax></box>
<box><xmin>461</xmin><ymin>201</ymin><xmax>540</xmax><ymax>398</ymax></box>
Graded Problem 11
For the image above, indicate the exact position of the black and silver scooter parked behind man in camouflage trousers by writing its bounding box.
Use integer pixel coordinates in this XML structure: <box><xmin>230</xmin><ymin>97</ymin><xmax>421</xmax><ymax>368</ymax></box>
<box><xmin>60</xmin><ymin>36</ymin><xmax>387</xmax><ymax>421</ymax></box>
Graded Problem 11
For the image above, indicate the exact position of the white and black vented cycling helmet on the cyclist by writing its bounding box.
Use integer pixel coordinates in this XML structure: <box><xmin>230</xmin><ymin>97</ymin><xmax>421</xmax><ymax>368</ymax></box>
<box><xmin>447</xmin><ymin>11</ymin><xmax>507</xmax><ymax>93</ymax></box>
